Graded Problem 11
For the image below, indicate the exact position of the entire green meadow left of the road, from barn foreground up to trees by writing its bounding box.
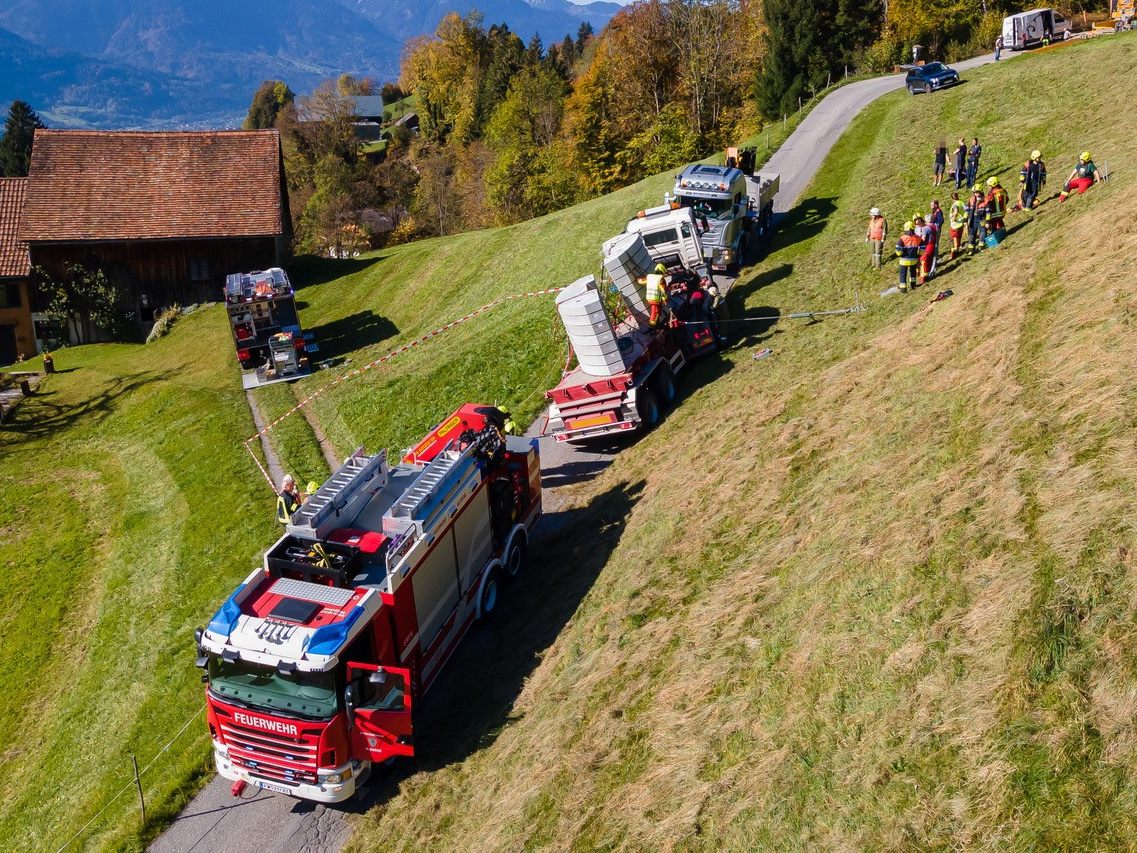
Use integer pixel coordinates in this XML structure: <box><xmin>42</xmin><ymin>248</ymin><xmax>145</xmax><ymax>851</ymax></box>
<box><xmin>0</xmin><ymin>81</ymin><xmax>818</xmax><ymax>848</ymax></box>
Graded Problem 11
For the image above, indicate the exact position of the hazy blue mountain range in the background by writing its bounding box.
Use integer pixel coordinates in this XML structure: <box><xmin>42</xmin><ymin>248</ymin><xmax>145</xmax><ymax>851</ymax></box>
<box><xmin>0</xmin><ymin>0</ymin><xmax>620</xmax><ymax>129</ymax></box>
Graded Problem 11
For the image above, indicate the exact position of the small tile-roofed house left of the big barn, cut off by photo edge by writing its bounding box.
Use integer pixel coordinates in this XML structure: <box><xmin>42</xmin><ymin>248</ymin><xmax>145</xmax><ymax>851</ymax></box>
<box><xmin>0</xmin><ymin>177</ymin><xmax>35</xmax><ymax>364</ymax></box>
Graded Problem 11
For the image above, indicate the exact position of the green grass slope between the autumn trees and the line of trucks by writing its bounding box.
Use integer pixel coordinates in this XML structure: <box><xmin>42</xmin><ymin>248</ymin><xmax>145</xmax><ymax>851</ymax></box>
<box><xmin>249</xmin><ymin>99</ymin><xmax>804</xmax><ymax>480</ymax></box>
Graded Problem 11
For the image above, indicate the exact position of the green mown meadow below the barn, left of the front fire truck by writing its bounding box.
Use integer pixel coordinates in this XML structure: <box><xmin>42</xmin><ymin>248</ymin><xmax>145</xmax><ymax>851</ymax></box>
<box><xmin>0</xmin><ymin>307</ymin><xmax>274</xmax><ymax>850</ymax></box>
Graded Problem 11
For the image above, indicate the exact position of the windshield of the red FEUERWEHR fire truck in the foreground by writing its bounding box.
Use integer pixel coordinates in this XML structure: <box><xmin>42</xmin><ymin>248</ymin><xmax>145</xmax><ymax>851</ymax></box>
<box><xmin>209</xmin><ymin>657</ymin><xmax>339</xmax><ymax>720</ymax></box>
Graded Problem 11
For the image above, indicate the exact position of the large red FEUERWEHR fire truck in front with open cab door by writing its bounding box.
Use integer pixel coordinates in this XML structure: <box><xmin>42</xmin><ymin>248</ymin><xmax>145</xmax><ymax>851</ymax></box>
<box><xmin>197</xmin><ymin>404</ymin><xmax>541</xmax><ymax>803</ymax></box>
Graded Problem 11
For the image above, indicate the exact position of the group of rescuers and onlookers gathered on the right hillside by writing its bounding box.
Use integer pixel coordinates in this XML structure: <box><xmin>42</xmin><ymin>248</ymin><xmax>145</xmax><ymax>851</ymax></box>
<box><xmin>865</xmin><ymin>142</ymin><xmax>1103</xmax><ymax>292</ymax></box>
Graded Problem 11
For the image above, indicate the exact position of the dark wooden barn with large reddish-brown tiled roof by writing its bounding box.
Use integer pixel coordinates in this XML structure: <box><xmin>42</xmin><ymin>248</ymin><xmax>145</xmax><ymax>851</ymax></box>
<box><xmin>19</xmin><ymin>130</ymin><xmax>290</xmax><ymax>332</ymax></box>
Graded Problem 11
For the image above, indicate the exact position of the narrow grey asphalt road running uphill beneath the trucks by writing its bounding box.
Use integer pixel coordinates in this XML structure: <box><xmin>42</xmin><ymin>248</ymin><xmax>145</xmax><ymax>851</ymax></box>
<box><xmin>150</xmin><ymin>57</ymin><xmax>990</xmax><ymax>853</ymax></box>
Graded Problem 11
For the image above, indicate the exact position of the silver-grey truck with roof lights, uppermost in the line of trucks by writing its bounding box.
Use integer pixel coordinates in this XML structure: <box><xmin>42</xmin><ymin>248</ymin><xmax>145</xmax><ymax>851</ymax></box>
<box><xmin>671</xmin><ymin>158</ymin><xmax>781</xmax><ymax>272</ymax></box>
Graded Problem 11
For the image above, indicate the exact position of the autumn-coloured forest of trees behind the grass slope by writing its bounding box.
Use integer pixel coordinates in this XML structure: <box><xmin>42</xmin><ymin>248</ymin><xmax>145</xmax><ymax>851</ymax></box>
<box><xmin>246</xmin><ymin>0</ymin><xmax>1093</xmax><ymax>254</ymax></box>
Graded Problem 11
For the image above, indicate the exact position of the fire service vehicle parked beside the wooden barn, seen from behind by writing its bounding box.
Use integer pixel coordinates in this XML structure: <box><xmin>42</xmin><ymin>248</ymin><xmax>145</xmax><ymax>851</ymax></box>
<box><xmin>225</xmin><ymin>266</ymin><xmax>319</xmax><ymax>390</ymax></box>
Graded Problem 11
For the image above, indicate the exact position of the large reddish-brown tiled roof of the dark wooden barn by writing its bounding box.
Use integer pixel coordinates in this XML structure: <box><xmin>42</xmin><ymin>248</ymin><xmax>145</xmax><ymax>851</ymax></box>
<box><xmin>19</xmin><ymin>130</ymin><xmax>285</xmax><ymax>242</ymax></box>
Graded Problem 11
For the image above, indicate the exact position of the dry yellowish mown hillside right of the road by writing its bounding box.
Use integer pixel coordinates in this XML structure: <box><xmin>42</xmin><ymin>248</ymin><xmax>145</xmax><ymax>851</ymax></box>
<box><xmin>343</xmin><ymin>36</ymin><xmax>1137</xmax><ymax>850</ymax></box>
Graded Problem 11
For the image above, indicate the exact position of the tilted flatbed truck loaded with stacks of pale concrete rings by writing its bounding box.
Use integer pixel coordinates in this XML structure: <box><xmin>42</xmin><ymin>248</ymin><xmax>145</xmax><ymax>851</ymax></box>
<box><xmin>545</xmin><ymin>234</ymin><xmax>717</xmax><ymax>441</ymax></box>
